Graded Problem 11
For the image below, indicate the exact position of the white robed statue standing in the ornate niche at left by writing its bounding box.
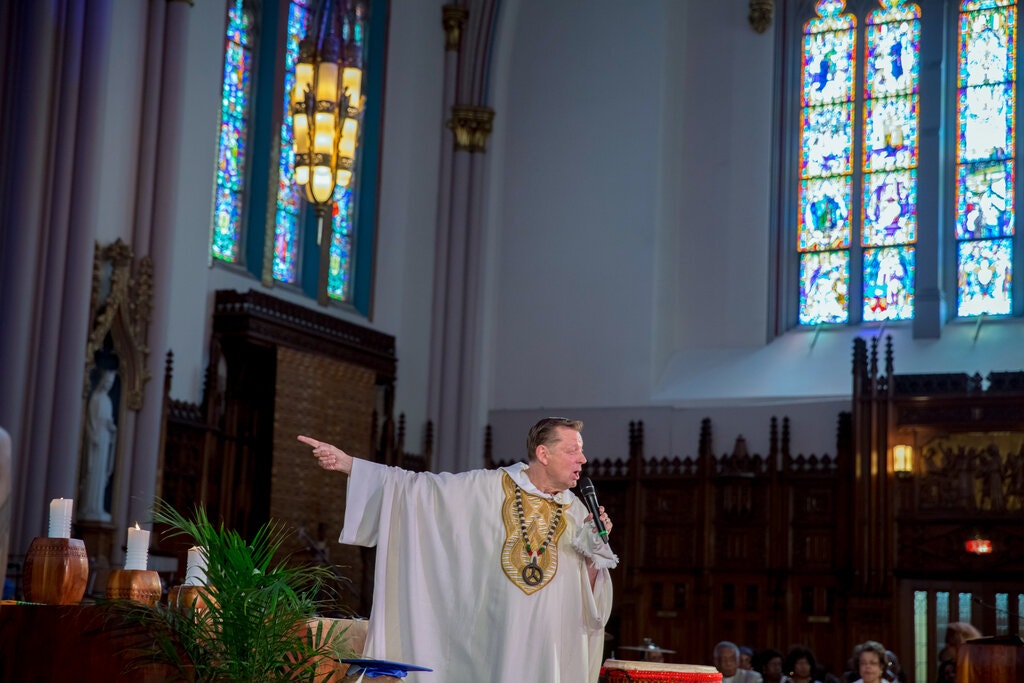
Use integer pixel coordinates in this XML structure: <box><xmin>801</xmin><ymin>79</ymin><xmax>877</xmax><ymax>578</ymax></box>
<box><xmin>78</xmin><ymin>370</ymin><xmax>118</xmax><ymax>522</ymax></box>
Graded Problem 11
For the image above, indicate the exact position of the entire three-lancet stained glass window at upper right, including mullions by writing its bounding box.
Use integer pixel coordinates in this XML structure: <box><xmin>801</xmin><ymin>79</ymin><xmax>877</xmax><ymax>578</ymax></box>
<box><xmin>783</xmin><ymin>0</ymin><xmax>1021</xmax><ymax>327</ymax></box>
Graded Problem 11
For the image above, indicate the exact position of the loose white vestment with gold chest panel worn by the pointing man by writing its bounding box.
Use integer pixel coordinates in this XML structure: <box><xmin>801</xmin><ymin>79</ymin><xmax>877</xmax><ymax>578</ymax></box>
<box><xmin>340</xmin><ymin>460</ymin><xmax>617</xmax><ymax>683</ymax></box>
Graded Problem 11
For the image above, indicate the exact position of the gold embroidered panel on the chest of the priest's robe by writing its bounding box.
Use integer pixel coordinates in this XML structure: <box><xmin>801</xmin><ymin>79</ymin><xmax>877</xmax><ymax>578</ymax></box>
<box><xmin>502</xmin><ymin>472</ymin><xmax>567</xmax><ymax>595</ymax></box>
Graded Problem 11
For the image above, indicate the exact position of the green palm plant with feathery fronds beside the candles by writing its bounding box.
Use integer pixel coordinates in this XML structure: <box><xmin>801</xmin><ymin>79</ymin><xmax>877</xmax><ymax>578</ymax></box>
<box><xmin>110</xmin><ymin>501</ymin><xmax>354</xmax><ymax>683</ymax></box>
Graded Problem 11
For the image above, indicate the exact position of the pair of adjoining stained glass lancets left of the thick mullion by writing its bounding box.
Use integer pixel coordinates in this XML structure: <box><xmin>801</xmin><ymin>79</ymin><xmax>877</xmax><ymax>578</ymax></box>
<box><xmin>797</xmin><ymin>0</ymin><xmax>921</xmax><ymax>326</ymax></box>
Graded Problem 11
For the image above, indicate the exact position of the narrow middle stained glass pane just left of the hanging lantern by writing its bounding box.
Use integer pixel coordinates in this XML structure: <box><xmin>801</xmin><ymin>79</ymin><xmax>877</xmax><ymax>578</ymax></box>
<box><xmin>273</xmin><ymin>0</ymin><xmax>312</xmax><ymax>284</ymax></box>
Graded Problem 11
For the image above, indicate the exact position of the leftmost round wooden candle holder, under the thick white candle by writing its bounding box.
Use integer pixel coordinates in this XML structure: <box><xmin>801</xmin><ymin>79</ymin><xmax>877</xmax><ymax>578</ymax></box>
<box><xmin>23</xmin><ymin>537</ymin><xmax>89</xmax><ymax>605</ymax></box>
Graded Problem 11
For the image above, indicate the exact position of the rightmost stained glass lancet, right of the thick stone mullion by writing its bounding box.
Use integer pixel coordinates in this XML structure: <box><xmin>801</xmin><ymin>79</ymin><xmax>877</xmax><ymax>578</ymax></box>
<box><xmin>955</xmin><ymin>0</ymin><xmax>1017</xmax><ymax>317</ymax></box>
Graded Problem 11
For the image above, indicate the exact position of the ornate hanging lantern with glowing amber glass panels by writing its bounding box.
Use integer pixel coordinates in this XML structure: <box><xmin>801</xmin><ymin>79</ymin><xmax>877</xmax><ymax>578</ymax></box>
<box><xmin>292</xmin><ymin>0</ymin><xmax>364</xmax><ymax>289</ymax></box>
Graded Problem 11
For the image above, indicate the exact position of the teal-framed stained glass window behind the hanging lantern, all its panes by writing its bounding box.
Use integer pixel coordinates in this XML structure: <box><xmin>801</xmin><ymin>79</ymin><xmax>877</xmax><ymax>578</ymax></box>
<box><xmin>211</xmin><ymin>0</ymin><xmax>387</xmax><ymax>313</ymax></box>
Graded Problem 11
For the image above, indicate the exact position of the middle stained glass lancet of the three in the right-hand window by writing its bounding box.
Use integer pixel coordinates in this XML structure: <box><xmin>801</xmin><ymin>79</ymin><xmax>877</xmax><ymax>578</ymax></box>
<box><xmin>860</xmin><ymin>0</ymin><xmax>921</xmax><ymax>322</ymax></box>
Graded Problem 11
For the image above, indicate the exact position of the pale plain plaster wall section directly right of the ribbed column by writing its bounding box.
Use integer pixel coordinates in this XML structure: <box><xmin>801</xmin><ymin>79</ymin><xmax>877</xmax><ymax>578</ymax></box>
<box><xmin>490</xmin><ymin>0</ymin><xmax>667</xmax><ymax>410</ymax></box>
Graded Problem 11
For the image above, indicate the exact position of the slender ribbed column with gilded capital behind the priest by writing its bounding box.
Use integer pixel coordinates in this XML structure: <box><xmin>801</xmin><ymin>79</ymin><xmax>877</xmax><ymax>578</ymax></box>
<box><xmin>427</xmin><ymin>0</ymin><xmax>498</xmax><ymax>471</ymax></box>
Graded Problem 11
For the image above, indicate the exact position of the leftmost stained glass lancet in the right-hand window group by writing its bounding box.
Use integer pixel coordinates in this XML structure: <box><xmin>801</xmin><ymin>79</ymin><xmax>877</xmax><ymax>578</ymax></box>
<box><xmin>798</xmin><ymin>0</ymin><xmax>857</xmax><ymax>325</ymax></box>
